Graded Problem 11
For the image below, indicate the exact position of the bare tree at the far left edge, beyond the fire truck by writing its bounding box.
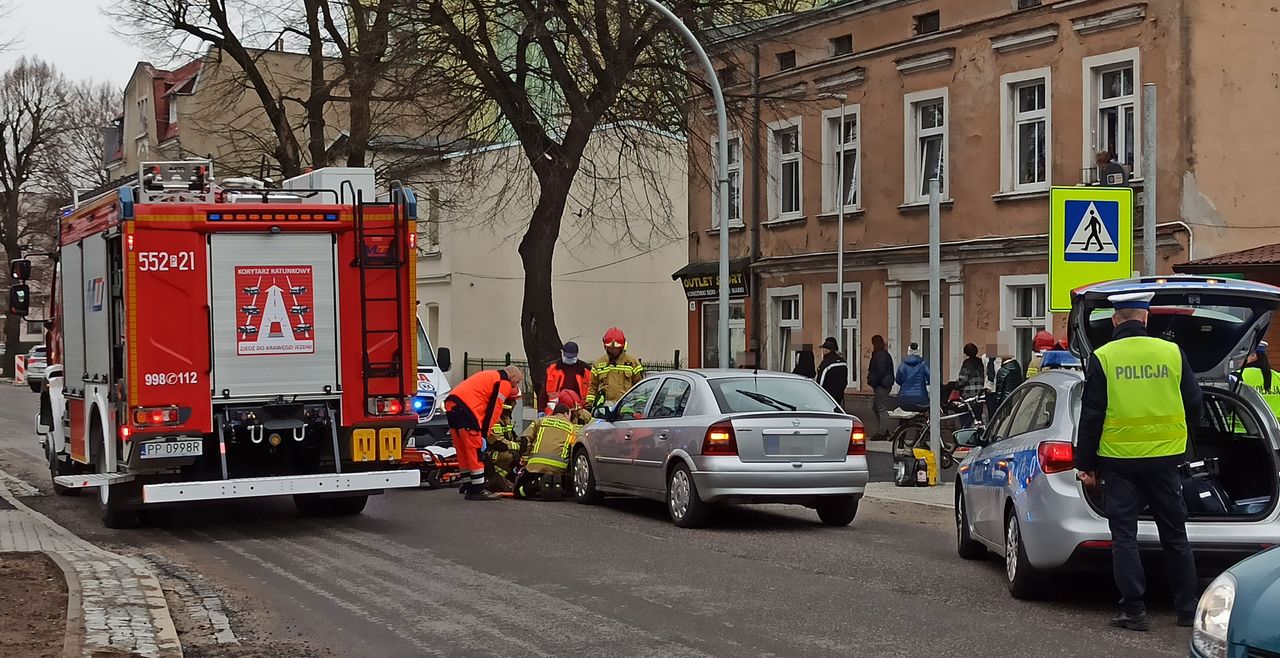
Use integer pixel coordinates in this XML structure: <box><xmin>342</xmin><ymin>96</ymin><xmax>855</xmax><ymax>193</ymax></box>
<box><xmin>0</xmin><ymin>58</ymin><xmax>70</xmax><ymax>374</ymax></box>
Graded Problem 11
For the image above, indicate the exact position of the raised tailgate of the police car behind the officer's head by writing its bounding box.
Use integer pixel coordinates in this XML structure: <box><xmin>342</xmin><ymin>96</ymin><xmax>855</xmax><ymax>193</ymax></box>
<box><xmin>1069</xmin><ymin>277</ymin><xmax>1280</xmax><ymax>381</ymax></box>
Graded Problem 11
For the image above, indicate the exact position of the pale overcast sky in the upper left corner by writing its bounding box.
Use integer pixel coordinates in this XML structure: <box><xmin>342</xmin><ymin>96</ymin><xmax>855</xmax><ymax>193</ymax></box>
<box><xmin>0</xmin><ymin>0</ymin><xmax>147</xmax><ymax>87</ymax></box>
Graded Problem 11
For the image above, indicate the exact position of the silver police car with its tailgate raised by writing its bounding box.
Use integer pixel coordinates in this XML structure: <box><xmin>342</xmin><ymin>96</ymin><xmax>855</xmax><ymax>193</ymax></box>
<box><xmin>955</xmin><ymin>277</ymin><xmax>1280</xmax><ymax>598</ymax></box>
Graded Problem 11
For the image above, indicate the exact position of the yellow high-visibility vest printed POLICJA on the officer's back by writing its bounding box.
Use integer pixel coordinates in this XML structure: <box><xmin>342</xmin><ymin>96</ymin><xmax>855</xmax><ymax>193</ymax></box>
<box><xmin>1096</xmin><ymin>335</ymin><xmax>1187</xmax><ymax>460</ymax></box>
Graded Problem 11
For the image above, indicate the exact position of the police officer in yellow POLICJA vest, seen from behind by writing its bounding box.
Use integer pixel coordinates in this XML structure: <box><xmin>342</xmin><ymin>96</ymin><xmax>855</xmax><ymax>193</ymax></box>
<box><xmin>1075</xmin><ymin>293</ymin><xmax>1201</xmax><ymax>631</ymax></box>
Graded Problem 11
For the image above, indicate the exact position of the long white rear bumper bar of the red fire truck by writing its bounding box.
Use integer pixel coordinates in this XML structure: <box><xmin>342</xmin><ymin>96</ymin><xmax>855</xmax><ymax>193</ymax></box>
<box><xmin>142</xmin><ymin>470</ymin><xmax>421</xmax><ymax>503</ymax></box>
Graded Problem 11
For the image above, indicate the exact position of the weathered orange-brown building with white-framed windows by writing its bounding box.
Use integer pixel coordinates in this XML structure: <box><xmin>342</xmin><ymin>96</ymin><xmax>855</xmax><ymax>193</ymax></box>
<box><xmin>689</xmin><ymin>0</ymin><xmax>1280</xmax><ymax>409</ymax></box>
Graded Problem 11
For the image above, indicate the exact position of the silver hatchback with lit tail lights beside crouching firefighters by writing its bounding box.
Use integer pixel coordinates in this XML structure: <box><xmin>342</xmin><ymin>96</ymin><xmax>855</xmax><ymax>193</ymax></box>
<box><xmin>572</xmin><ymin>370</ymin><xmax>868</xmax><ymax>527</ymax></box>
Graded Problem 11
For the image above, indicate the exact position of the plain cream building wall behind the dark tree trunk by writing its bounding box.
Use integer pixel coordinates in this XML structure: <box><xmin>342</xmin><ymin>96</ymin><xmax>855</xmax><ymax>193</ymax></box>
<box><xmin>416</xmin><ymin>127</ymin><xmax>689</xmax><ymax>371</ymax></box>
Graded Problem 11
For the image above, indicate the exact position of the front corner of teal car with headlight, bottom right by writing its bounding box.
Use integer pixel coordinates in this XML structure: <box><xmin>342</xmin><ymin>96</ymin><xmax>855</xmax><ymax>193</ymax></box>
<box><xmin>1190</xmin><ymin>548</ymin><xmax>1280</xmax><ymax>658</ymax></box>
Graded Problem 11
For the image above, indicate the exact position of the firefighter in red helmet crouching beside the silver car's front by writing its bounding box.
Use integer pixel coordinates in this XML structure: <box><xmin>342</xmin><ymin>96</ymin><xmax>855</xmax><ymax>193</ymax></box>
<box><xmin>516</xmin><ymin>389</ymin><xmax>582</xmax><ymax>499</ymax></box>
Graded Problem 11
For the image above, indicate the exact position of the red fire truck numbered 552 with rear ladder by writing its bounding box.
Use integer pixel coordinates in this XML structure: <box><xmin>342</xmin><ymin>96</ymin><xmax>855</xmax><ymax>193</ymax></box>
<box><xmin>10</xmin><ymin>161</ymin><xmax>419</xmax><ymax>527</ymax></box>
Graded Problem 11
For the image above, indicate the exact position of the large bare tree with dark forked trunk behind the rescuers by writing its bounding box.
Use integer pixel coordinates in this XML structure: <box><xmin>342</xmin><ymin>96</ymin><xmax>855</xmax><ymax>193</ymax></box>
<box><xmin>417</xmin><ymin>0</ymin><xmax>794</xmax><ymax>378</ymax></box>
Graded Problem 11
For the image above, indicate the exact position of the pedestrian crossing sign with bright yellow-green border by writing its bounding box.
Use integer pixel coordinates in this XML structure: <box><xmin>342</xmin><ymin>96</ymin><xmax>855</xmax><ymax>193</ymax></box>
<box><xmin>1048</xmin><ymin>187</ymin><xmax>1133</xmax><ymax>312</ymax></box>
